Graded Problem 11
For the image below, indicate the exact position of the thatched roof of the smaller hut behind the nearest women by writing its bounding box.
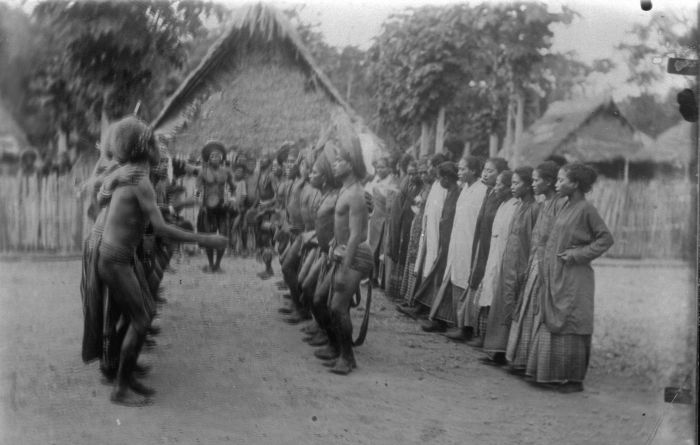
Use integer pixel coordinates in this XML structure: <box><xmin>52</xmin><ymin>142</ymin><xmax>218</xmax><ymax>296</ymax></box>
<box><xmin>518</xmin><ymin>96</ymin><xmax>641</xmax><ymax>165</ymax></box>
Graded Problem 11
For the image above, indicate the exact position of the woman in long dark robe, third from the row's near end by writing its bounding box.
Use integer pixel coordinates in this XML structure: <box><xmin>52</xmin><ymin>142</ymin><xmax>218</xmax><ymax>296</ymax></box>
<box><xmin>482</xmin><ymin>167</ymin><xmax>539</xmax><ymax>366</ymax></box>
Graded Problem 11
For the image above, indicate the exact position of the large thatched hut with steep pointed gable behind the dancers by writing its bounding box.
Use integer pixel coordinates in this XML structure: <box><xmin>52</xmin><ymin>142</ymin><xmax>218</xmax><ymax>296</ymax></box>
<box><xmin>153</xmin><ymin>3</ymin><xmax>383</xmax><ymax>174</ymax></box>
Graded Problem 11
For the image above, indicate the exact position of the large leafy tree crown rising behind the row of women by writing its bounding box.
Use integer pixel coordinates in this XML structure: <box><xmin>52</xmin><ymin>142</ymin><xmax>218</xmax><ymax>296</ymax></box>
<box><xmin>368</xmin><ymin>2</ymin><xmax>589</xmax><ymax>152</ymax></box>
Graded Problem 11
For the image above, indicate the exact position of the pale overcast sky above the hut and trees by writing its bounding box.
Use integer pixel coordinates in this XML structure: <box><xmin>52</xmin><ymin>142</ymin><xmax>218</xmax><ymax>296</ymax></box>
<box><xmin>276</xmin><ymin>0</ymin><xmax>697</xmax><ymax>99</ymax></box>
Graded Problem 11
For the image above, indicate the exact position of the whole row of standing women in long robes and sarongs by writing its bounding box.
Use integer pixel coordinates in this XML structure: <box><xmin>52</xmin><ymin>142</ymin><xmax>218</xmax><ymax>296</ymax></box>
<box><xmin>368</xmin><ymin>154</ymin><xmax>613</xmax><ymax>392</ymax></box>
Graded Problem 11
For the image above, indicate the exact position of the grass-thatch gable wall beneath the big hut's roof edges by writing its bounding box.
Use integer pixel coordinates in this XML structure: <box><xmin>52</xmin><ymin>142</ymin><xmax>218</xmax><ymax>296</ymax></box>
<box><xmin>169</xmin><ymin>51</ymin><xmax>337</xmax><ymax>154</ymax></box>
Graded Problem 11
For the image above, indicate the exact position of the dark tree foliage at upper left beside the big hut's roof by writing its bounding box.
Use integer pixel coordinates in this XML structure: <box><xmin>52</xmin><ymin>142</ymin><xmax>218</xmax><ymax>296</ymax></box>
<box><xmin>30</xmin><ymin>1</ymin><xmax>222</xmax><ymax>150</ymax></box>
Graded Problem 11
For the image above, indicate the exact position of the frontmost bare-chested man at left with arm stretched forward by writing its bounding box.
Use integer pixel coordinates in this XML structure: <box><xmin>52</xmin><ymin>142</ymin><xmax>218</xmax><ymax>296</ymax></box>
<box><xmin>97</xmin><ymin>117</ymin><xmax>228</xmax><ymax>406</ymax></box>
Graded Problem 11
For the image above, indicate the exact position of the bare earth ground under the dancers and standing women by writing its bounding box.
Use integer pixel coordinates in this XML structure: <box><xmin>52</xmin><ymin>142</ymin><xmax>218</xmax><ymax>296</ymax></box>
<box><xmin>0</xmin><ymin>256</ymin><xmax>695</xmax><ymax>445</ymax></box>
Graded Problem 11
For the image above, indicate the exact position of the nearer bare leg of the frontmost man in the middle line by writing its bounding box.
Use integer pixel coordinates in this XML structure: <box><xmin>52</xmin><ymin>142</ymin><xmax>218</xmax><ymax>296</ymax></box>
<box><xmin>330</xmin><ymin>267</ymin><xmax>362</xmax><ymax>375</ymax></box>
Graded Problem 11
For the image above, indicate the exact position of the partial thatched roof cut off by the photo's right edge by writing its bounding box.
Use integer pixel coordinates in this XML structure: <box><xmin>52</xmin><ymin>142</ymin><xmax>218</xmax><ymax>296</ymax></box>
<box><xmin>631</xmin><ymin>121</ymin><xmax>698</xmax><ymax>168</ymax></box>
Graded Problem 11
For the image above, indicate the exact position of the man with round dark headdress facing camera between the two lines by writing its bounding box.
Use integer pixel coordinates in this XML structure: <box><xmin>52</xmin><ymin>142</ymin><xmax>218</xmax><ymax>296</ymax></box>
<box><xmin>196</xmin><ymin>141</ymin><xmax>235</xmax><ymax>272</ymax></box>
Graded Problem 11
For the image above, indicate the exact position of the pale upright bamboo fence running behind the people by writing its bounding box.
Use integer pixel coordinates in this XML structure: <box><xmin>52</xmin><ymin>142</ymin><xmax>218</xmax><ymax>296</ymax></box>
<box><xmin>0</xmin><ymin>175</ymin><xmax>695</xmax><ymax>259</ymax></box>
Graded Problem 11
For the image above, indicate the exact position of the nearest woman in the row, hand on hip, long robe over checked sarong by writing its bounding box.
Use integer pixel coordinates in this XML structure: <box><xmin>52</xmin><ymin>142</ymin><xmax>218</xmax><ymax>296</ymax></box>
<box><xmin>526</xmin><ymin>163</ymin><xmax>613</xmax><ymax>393</ymax></box>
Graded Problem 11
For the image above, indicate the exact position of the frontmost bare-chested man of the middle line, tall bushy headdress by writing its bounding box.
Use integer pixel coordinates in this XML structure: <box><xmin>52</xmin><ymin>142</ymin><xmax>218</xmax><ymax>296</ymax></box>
<box><xmin>315</xmin><ymin>122</ymin><xmax>374</xmax><ymax>375</ymax></box>
